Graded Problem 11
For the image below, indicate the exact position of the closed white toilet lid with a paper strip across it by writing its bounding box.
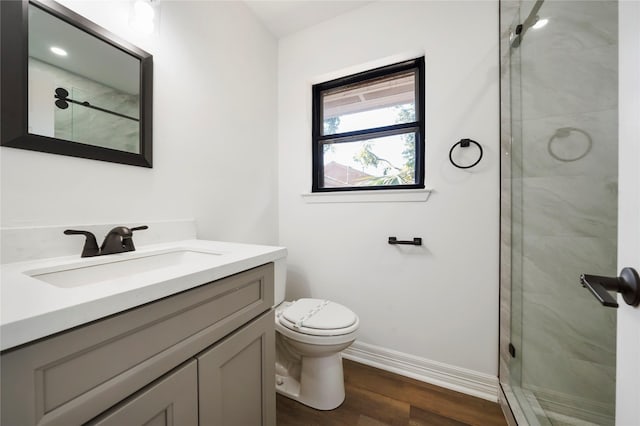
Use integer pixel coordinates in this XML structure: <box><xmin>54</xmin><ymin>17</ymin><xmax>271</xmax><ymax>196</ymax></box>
<box><xmin>280</xmin><ymin>299</ymin><xmax>358</xmax><ymax>335</ymax></box>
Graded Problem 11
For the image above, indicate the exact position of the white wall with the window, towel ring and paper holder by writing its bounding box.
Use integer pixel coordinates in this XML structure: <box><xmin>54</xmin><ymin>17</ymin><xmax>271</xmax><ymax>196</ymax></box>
<box><xmin>278</xmin><ymin>1</ymin><xmax>499</xmax><ymax>377</ymax></box>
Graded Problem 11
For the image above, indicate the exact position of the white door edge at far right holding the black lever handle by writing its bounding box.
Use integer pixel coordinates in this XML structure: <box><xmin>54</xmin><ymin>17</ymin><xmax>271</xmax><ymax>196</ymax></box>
<box><xmin>616</xmin><ymin>1</ymin><xmax>640</xmax><ymax>426</ymax></box>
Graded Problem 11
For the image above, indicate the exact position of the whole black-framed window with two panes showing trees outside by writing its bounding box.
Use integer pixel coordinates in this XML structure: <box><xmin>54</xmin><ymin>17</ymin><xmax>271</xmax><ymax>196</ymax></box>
<box><xmin>312</xmin><ymin>57</ymin><xmax>424</xmax><ymax>192</ymax></box>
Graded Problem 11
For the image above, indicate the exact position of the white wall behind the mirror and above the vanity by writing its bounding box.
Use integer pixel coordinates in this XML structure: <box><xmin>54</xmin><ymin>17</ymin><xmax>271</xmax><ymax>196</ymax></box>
<box><xmin>0</xmin><ymin>0</ymin><xmax>277</xmax><ymax>244</ymax></box>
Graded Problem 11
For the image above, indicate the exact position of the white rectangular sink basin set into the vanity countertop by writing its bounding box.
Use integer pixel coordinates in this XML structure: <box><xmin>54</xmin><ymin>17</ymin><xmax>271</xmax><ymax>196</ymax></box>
<box><xmin>25</xmin><ymin>249</ymin><xmax>220</xmax><ymax>288</ymax></box>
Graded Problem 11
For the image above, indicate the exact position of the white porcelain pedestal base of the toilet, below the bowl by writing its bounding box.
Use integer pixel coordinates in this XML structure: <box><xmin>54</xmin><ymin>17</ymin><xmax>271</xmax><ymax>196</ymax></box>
<box><xmin>276</xmin><ymin>353</ymin><xmax>345</xmax><ymax>410</ymax></box>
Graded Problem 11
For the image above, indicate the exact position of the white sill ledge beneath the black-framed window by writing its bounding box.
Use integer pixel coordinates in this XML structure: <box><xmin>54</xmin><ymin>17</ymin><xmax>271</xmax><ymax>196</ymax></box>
<box><xmin>301</xmin><ymin>189</ymin><xmax>433</xmax><ymax>203</ymax></box>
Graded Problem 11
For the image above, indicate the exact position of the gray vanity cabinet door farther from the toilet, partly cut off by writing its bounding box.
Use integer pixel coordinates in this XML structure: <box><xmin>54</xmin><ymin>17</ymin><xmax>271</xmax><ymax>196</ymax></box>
<box><xmin>87</xmin><ymin>360</ymin><xmax>198</xmax><ymax>426</ymax></box>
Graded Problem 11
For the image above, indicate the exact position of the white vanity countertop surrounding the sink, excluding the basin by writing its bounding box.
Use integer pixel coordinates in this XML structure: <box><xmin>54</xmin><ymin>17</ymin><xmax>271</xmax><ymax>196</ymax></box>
<box><xmin>0</xmin><ymin>240</ymin><xmax>287</xmax><ymax>350</ymax></box>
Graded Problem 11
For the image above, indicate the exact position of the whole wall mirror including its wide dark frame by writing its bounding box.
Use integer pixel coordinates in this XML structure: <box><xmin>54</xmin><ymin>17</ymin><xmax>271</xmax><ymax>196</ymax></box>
<box><xmin>0</xmin><ymin>0</ymin><xmax>153</xmax><ymax>167</ymax></box>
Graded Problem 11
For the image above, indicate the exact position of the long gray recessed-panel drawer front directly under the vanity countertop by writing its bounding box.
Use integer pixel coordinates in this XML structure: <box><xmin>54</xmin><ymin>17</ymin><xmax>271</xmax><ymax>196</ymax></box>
<box><xmin>1</xmin><ymin>264</ymin><xmax>273</xmax><ymax>426</ymax></box>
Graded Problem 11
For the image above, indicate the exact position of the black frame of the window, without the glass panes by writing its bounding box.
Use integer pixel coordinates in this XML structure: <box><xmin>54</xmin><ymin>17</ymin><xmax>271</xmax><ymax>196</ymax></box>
<box><xmin>311</xmin><ymin>56</ymin><xmax>425</xmax><ymax>192</ymax></box>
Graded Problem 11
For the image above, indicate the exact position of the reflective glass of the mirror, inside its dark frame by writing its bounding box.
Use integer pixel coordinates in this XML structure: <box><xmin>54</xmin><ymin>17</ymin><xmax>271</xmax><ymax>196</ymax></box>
<box><xmin>28</xmin><ymin>4</ymin><xmax>141</xmax><ymax>154</ymax></box>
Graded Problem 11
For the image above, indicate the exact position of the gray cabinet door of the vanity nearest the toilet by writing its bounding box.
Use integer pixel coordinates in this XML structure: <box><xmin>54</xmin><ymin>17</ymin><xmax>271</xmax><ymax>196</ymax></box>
<box><xmin>197</xmin><ymin>310</ymin><xmax>276</xmax><ymax>426</ymax></box>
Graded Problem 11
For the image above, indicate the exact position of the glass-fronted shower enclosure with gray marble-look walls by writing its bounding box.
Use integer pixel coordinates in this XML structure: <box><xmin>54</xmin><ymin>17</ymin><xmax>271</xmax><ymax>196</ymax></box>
<box><xmin>500</xmin><ymin>0</ymin><xmax>618</xmax><ymax>425</ymax></box>
